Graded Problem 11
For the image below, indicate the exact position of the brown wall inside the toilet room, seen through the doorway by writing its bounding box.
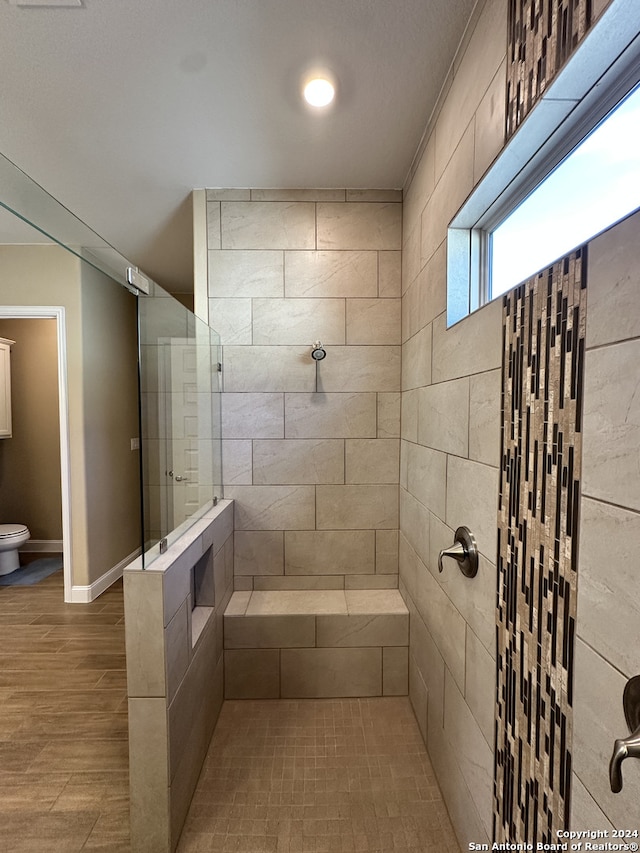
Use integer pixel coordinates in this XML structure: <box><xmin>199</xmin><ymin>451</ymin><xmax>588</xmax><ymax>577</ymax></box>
<box><xmin>0</xmin><ymin>319</ymin><xmax>62</xmax><ymax>541</ymax></box>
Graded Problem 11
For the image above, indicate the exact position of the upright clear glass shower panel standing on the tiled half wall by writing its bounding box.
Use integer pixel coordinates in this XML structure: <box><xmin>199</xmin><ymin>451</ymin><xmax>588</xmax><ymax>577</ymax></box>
<box><xmin>138</xmin><ymin>284</ymin><xmax>222</xmax><ymax>568</ymax></box>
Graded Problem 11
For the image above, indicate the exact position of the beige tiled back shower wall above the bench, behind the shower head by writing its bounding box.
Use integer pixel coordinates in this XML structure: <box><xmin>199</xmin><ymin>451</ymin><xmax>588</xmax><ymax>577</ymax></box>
<box><xmin>207</xmin><ymin>190</ymin><xmax>402</xmax><ymax>589</ymax></box>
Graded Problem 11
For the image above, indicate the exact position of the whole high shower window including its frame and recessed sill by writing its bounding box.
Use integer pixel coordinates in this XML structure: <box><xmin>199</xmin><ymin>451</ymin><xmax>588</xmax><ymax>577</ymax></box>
<box><xmin>447</xmin><ymin>0</ymin><xmax>640</xmax><ymax>326</ymax></box>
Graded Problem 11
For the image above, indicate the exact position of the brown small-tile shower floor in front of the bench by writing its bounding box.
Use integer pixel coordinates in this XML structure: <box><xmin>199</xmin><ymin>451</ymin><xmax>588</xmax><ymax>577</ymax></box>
<box><xmin>178</xmin><ymin>697</ymin><xmax>459</xmax><ymax>853</ymax></box>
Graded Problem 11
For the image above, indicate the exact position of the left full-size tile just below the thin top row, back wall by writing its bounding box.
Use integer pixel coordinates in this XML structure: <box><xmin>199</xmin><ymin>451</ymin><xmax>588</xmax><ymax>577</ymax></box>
<box><xmin>221</xmin><ymin>201</ymin><xmax>316</xmax><ymax>249</ymax></box>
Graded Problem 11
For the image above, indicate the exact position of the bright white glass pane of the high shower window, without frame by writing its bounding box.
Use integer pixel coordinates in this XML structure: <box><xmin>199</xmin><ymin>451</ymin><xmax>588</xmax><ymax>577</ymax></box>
<box><xmin>488</xmin><ymin>80</ymin><xmax>640</xmax><ymax>299</ymax></box>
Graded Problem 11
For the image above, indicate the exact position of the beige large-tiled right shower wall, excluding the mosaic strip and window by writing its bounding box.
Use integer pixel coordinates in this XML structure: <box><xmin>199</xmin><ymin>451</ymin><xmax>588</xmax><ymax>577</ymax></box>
<box><xmin>400</xmin><ymin>0</ymin><xmax>640</xmax><ymax>846</ymax></box>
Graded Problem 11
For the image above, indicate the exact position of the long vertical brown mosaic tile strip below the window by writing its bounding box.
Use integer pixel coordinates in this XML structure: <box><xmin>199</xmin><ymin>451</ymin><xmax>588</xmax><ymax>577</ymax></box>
<box><xmin>494</xmin><ymin>247</ymin><xmax>586</xmax><ymax>849</ymax></box>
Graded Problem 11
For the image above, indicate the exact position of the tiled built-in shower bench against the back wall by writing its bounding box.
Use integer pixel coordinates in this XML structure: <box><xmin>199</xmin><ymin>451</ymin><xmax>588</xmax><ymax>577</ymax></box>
<box><xmin>224</xmin><ymin>589</ymin><xmax>409</xmax><ymax>699</ymax></box>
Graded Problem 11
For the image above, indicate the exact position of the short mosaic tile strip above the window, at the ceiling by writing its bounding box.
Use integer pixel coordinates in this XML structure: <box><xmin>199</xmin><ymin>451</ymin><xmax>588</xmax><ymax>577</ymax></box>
<box><xmin>506</xmin><ymin>0</ymin><xmax>592</xmax><ymax>139</ymax></box>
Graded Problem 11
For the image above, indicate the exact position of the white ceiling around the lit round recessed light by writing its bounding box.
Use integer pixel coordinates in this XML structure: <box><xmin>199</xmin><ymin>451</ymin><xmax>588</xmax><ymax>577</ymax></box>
<box><xmin>0</xmin><ymin>0</ymin><xmax>475</xmax><ymax>290</ymax></box>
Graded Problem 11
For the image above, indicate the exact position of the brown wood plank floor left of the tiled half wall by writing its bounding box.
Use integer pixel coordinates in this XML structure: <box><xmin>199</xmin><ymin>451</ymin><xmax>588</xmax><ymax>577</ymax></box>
<box><xmin>0</xmin><ymin>571</ymin><xmax>131</xmax><ymax>853</ymax></box>
